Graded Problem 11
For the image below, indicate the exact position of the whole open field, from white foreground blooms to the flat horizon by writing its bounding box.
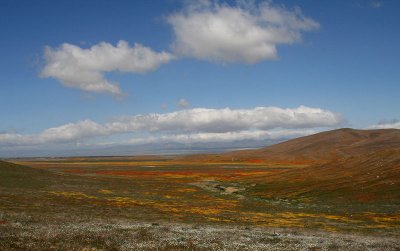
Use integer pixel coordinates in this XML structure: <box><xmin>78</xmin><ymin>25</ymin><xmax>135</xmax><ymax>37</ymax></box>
<box><xmin>0</xmin><ymin>152</ymin><xmax>400</xmax><ymax>250</ymax></box>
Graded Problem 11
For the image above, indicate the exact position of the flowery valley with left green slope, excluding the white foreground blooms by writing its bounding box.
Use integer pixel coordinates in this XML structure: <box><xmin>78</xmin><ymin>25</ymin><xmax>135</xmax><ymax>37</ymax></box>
<box><xmin>0</xmin><ymin>157</ymin><xmax>400</xmax><ymax>250</ymax></box>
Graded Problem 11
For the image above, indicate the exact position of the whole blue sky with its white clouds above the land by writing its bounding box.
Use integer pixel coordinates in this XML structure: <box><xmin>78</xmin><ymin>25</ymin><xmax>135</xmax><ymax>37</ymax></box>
<box><xmin>0</xmin><ymin>0</ymin><xmax>400</xmax><ymax>157</ymax></box>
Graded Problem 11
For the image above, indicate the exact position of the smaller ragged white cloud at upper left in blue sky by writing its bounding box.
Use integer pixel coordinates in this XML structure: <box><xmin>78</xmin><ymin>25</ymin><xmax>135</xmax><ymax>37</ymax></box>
<box><xmin>41</xmin><ymin>40</ymin><xmax>174</xmax><ymax>96</ymax></box>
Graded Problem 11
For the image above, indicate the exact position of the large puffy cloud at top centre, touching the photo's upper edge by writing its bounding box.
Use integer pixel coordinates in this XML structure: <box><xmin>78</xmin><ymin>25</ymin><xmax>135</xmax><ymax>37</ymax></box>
<box><xmin>167</xmin><ymin>1</ymin><xmax>319</xmax><ymax>63</ymax></box>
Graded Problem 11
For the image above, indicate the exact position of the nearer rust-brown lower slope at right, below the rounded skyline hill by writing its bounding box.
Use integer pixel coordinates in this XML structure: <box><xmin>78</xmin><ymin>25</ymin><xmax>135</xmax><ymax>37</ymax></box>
<box><xmin>247</xmin><ymin>149</ymin><xmax>400</xmax><ymax>202</ymax></box>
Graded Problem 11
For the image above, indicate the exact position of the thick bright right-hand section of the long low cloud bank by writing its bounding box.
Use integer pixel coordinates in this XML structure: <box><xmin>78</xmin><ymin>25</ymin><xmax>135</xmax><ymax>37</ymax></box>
<box><xmin>107</xmin><ymin>106</ymin><xmax>342</xmax><ymax>133</ymax></box>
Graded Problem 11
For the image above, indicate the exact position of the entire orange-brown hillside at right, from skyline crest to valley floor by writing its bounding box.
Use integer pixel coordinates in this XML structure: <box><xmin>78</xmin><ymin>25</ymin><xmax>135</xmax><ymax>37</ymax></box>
<box><xmin>213</xmin><ymin>129</ymin><xmax>400</xmax><ymax>205</ymax></box>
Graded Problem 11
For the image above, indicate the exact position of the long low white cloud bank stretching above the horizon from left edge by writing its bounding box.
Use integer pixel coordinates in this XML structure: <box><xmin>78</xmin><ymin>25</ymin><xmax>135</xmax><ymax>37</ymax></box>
<box><xmin>0</xmin><ymin>106</ymin><xmax>343</xmax><ymax>146</ymax></box>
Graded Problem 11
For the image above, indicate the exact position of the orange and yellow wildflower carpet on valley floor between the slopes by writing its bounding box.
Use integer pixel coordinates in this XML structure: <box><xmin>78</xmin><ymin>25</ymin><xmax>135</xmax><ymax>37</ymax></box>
<box><xmin>10</xmin><ymin>157</ymin><xmax>400</xmax><ymax>235</ymax></box>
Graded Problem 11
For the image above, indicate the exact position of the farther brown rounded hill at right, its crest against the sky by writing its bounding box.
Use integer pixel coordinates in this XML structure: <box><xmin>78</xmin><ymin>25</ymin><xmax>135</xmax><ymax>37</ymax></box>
<box><xmin>185</xmin><ymin>128</ymin><xmax>400</xmax><ymax>164</ymax></box>
